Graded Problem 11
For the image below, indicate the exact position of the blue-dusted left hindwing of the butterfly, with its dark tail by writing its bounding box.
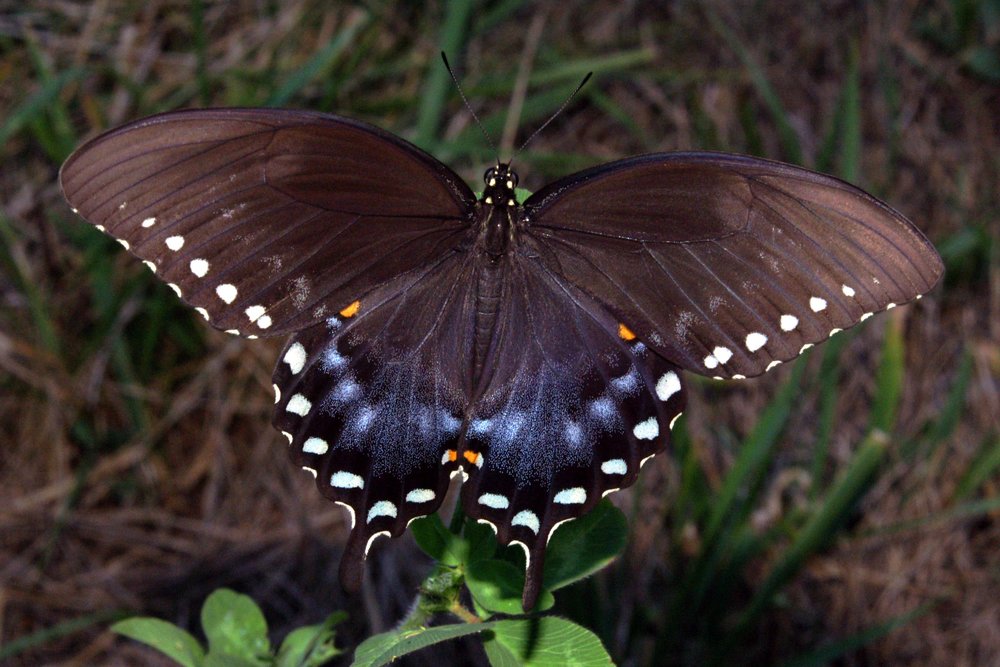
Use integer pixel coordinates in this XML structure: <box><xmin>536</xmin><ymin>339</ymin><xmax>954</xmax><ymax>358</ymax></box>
<box><xmin>274</xmin><ymin>253</ymin><xmax>476</xmax><ymax>590</ymax></box>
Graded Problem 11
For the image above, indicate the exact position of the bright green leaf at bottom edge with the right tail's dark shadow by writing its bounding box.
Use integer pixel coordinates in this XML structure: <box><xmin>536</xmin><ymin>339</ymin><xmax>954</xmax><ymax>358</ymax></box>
<box><xmin>493</xmin><ymin>616</ymin><xmax>614</xmax><ymax>667</ymax></box>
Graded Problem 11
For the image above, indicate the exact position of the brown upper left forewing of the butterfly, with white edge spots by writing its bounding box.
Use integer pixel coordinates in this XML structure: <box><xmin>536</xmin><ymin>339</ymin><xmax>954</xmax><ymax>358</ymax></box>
<box><xmin>60</xmin><ymin>109</ymin><xmax>475</xmax><ymax>335</ymax></box>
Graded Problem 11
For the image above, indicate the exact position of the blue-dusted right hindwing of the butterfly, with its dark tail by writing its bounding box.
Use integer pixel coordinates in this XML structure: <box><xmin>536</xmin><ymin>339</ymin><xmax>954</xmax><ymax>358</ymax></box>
<box><xmin>461</xmin><ymin>245</ymin><xmax>684</xmax><ymax>609</ymax></box>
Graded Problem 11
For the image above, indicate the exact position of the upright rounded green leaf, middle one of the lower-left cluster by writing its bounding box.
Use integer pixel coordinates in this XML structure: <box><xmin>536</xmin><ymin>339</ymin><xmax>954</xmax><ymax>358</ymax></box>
<box><xmin>201</xmin><ymin>588</ymin><xmax>271</xmax><ymax>664</ymax></box>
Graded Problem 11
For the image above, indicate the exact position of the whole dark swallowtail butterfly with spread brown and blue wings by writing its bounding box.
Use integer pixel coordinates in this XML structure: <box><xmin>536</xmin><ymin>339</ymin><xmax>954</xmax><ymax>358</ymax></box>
<box><xmin>60</xmin><ymin>109</ymin><xmax>942</xmax><ymax>609</ymax></box>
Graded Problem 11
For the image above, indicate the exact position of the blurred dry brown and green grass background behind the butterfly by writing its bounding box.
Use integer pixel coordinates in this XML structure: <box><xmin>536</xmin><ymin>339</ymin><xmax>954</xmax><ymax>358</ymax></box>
<box><xmin>0</xmin><ymin>0</ymin><xmax>1000</xmax><ymax>665</ymax></box>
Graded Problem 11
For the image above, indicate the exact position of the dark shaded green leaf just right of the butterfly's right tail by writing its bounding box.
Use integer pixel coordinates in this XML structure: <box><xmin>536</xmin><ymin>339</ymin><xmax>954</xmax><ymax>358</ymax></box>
<box><xmin>543</xmin><ymin>498</ymin><xmax>628</xmax><ymax>591</ymax></box>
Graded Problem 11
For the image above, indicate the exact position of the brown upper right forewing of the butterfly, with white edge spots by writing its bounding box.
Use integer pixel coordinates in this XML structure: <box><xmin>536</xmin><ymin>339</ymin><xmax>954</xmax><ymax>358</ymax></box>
<box><xmin>524</xmin><ymin>153</ymin><xmax>942</xmax><ymax>378</ymax></box>
